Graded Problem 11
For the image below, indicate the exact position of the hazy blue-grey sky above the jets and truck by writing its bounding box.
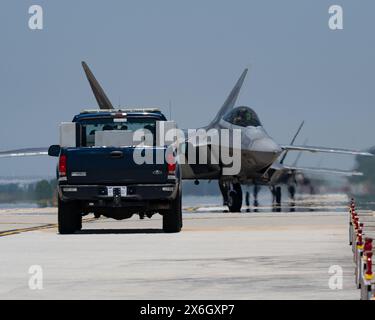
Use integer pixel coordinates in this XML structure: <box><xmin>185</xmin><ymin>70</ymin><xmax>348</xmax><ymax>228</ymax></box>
<box><xmin>0</xmin><ymin>0</ymin><xmax>375</xmax><ymax>176</ymax></box>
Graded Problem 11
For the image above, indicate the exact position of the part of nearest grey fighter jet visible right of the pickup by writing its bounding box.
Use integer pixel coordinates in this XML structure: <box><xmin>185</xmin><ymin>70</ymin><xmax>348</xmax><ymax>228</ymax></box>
<box><xmin>178</xmin><ymin>69</ymin><xmax>372</xmax><ymax>212</ymax></box>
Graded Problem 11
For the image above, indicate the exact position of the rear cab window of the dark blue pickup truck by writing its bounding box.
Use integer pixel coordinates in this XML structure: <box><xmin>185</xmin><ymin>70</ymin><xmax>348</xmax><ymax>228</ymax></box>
<box><xmin>80</xmin><ymin>118</ymin><xmax>156</xmax><ymax>147</ymax></box>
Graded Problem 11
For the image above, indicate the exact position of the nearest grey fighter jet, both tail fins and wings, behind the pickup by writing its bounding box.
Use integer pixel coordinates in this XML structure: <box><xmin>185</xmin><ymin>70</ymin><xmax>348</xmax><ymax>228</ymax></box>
<box><xmin>0</xmin><ymin>62</ymin><xmax>373</xmax><ymax>212</ymax></box>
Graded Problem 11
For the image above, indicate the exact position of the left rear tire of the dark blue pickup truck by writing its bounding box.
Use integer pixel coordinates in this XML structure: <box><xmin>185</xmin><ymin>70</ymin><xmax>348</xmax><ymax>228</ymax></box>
<box><xmin>57</xmin><ymin>198</ymin><xmax>82</xmax><ymax>234</ymax></box>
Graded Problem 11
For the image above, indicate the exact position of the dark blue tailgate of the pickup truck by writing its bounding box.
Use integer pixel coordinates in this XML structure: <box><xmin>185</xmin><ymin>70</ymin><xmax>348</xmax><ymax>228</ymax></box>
<box><xmin>65</xmin><ymin>147</ymin><xmax>168</xmax><ymax>185</ymax></box>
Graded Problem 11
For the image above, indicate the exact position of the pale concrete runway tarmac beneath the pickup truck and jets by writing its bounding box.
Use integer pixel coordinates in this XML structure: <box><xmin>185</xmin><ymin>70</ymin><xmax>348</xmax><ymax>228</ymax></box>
<box><xmin>0</xmin><ymin>195</ymin><xmax>359</xmax><ymax>299</ymax></box>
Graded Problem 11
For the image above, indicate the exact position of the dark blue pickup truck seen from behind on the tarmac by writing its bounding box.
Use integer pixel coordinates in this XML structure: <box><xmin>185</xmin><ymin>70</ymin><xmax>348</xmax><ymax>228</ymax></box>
<box><xmin>48</xmin><ymin>109</ymin><xmax>182</xmax><ymax>234</ymax></box>
